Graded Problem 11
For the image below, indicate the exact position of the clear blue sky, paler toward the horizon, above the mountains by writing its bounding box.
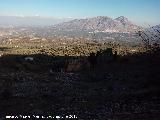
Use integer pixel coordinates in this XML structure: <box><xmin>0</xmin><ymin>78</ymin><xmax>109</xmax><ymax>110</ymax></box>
<box><xmin>0</xmin><ymin>0</ymin><xmax>160</xmax><ymax>25</ymax></box>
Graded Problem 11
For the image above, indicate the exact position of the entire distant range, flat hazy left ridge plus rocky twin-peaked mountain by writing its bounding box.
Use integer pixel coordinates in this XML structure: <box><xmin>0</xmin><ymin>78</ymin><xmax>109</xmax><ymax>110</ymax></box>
<box><xmin>0</xmin><ymin>16</ymin><xmax>140</xmax><ymax>33</ymax></box>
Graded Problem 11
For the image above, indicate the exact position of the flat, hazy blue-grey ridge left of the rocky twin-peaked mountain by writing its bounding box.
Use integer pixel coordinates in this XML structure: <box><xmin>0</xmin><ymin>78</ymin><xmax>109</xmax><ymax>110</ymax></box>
<box><xmin>0</xmin><ymin>16</ymin><xmax>71</xmax><ymax>27</ymax></box>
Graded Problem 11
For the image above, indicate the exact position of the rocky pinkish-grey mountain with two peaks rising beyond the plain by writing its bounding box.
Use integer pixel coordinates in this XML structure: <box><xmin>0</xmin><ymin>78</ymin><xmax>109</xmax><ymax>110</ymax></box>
<box><xmin>55</xmin><ymin>16</ymin><xmax>140</xmax><ymax>32</ymax></box>
